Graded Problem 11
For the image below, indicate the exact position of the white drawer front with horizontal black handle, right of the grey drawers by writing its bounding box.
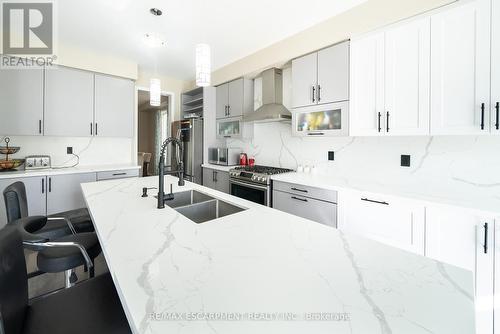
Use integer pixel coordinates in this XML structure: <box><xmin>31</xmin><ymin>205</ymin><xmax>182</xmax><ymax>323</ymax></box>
<box><xmin>338</xmin><ymin>191</ymin><xmax>425</xmax><ymax>255</ymax></box>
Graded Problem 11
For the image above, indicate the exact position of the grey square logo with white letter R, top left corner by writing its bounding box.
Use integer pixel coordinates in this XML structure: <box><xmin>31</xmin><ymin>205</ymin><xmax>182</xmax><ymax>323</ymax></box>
<box><xmin>2</xmin><ymin>2</ymin><xmax>54</xmax><ymax>55</ymax></box>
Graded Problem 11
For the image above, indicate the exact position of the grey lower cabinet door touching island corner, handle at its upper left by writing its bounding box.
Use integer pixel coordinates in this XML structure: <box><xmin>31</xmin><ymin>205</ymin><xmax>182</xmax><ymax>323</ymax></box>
<box><xmin>47</xmin><ymin>173</ymin><xmax>96</xmax><ymax>215</ymax></box>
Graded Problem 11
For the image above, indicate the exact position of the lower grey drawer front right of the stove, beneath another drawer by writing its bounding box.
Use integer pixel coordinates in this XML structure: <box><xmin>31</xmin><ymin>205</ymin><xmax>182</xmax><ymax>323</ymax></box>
<box><xmin>273</xmin><ymin>190</ymin><xmax>337</xmax><ymax>227</ymax></box>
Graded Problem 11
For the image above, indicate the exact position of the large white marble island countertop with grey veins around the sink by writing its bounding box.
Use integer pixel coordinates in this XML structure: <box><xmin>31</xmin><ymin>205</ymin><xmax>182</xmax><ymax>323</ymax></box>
<box><xmin>82</xmin><ymin>176</ymin><xmax>475</xmax><ymax>334</ymax></box>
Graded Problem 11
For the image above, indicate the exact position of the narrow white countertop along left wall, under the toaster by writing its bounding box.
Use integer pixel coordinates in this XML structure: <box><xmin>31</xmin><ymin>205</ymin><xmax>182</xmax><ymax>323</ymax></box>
<box><xmin>0</xmin><ymin>164</ymin><xmax>141</xmax><ymax>179</ymax></box>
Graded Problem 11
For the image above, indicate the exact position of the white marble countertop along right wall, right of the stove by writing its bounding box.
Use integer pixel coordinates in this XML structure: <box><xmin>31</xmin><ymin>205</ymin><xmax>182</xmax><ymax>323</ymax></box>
<box><xmin>271</xmin><ymin>172</ymin><xmax>500</xmax><ymax>218</ymax></box>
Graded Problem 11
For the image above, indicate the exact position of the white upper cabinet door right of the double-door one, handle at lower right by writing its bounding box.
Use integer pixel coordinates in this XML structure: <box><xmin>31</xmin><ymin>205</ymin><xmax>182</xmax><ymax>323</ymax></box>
<box><xmin>431</xmin><ymin>0</ymin><xmax>491</xmax><ymax>135</ymax></box>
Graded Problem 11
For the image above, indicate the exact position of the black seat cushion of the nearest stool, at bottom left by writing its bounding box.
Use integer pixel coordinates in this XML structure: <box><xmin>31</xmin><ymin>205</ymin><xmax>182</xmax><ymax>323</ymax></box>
<box><xmin>23</xmin><ymin>274</ymin><xmax>131</xmax><ymax>334</ymax></box>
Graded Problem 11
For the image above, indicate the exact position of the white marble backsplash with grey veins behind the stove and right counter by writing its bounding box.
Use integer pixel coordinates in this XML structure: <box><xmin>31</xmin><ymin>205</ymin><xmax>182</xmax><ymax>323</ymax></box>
<box><xmin>227</xmin><ymin>123</ymin><xmax>500</xmax><ymax>198</ymax></box>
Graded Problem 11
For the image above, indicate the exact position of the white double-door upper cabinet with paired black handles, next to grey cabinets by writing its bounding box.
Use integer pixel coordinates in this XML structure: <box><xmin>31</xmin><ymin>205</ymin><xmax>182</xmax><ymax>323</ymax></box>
<box><xmin>350</xmin><ymin>17</ymin><xmax>430</xmax><ymax>136</ymax></box>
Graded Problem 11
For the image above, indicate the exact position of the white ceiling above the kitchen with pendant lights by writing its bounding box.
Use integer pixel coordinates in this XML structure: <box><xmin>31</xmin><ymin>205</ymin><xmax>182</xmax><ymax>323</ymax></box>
<box><xmin>58</xmin><ymin>0</ymin><xmax>365</xmax><ymax>80</ymax></box>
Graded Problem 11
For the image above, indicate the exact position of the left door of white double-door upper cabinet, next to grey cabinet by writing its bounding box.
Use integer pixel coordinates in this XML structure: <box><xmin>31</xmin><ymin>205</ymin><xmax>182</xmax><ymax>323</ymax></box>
<box><xmin>349</xmin><ymin>33</ymin><xmax>385</xmax><ymax>136</ymax></box>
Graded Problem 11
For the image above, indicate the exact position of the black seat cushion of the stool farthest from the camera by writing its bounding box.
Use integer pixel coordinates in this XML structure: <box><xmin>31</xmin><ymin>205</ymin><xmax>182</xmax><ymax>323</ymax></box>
<box><xmin>36</xmin><ymin>208</ymin><xmax>94</xmax><ymax>239</ymax></box>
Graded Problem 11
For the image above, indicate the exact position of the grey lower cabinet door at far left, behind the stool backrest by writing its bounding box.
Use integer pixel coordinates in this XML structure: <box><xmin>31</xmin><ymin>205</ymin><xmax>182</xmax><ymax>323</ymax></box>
<box><xmin>0</xmin><ymin>176</ymin><xmax>46</xmax><ymax>228</ymax></box>
